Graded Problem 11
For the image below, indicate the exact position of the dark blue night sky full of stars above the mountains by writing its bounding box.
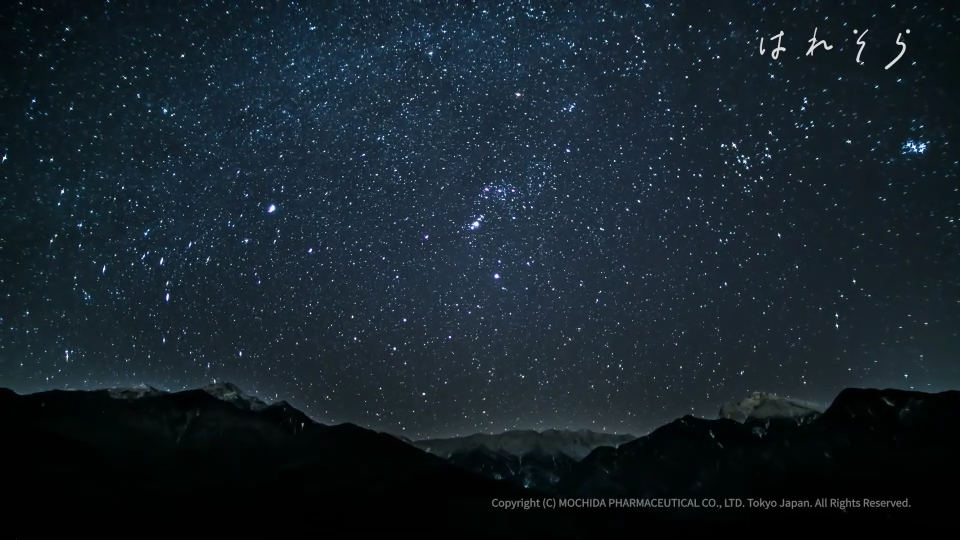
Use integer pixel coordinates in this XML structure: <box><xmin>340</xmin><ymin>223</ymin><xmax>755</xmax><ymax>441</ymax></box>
<box><xmin>0</xmin><ymin>0</ymin><xmax>960</xmax><ymax>438</ymax></box>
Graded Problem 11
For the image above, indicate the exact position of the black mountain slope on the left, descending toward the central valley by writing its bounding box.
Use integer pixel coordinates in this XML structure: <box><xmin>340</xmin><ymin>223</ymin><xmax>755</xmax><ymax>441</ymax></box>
<box><xmin>0</xmin><ymin>387</ymin><xmax>636</xmax><ymax>534</ymax></box>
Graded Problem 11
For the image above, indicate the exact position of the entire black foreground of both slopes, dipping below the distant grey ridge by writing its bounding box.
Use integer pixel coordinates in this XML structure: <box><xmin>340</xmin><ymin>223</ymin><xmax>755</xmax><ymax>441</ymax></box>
<box><xmin>0</xmin><ymin>389</ymin><xmax>960</xmax><ymax>535</ymax></box>
